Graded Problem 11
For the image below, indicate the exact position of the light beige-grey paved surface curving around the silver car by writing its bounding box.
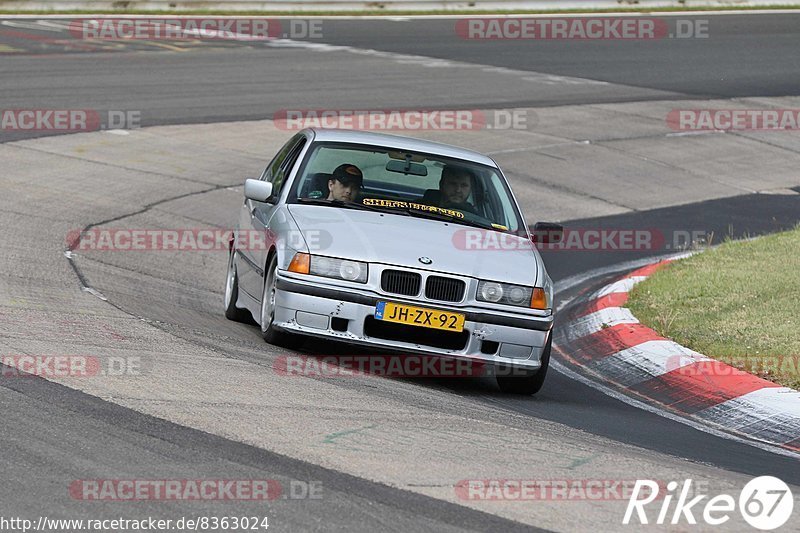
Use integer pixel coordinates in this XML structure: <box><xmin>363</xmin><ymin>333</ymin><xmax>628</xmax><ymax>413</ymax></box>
<box><xmin>0</xmin><ymin>98</ymin><xmax>800</xmax><ymax>531</ymax></box>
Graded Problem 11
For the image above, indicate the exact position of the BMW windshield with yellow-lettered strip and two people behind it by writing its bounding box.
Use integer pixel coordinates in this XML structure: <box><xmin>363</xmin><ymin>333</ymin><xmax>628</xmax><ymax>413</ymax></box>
<box><xmin>288</xmin><ymin>143</ymin><xmax>524</xmax><ymax>233</ymax></box>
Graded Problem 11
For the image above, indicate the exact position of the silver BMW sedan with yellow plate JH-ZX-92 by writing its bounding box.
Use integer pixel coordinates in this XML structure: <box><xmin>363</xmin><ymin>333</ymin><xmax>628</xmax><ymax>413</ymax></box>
<box><xmin>225</xmin><ymin>129</ymin><xmax>562</xmax><ymax>394</ymax></box>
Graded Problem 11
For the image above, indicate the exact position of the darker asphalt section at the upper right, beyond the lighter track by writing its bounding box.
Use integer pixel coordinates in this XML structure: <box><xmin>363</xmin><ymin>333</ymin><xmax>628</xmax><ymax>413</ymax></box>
<box><xmin>290</xmin><ymin>14</ymin><xmax>800</xmax><ymax>97</ymax></box>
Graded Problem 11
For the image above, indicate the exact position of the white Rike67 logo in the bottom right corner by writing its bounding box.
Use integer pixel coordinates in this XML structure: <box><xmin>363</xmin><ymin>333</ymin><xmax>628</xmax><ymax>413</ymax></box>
<box><xmin>622</xmin><ymin>476</ymin><xmax>794</xmax><ymax>531</ymax></box>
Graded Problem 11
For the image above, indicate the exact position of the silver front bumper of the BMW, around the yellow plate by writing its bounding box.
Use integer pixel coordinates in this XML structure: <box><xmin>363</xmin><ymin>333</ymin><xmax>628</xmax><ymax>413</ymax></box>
<box><xmin>274</xmin><ymin>271</ymin><xmax>553</xmax><ymax>370</ymax></box>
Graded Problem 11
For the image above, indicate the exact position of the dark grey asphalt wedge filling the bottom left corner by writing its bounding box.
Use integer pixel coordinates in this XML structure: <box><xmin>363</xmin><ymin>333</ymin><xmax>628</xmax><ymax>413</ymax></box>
<box><xmin>0</xmin><ymin>368</ymin><xmax>534</xmax><ymax>531</ymax></box>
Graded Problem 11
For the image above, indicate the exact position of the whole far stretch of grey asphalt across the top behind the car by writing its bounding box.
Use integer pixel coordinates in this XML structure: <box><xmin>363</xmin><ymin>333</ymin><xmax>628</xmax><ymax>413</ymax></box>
<box><xmin>0</xmin><ymin>14</ymin><xmax>800</xmax><ymax>141</ymax></box>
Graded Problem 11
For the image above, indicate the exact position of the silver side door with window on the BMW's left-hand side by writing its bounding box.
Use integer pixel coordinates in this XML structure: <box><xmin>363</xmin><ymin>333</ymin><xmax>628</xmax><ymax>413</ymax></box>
<box><xmin>237</xmin><ymin>134</ymin><xmax>307</xmax><ymax>300</ymax></box>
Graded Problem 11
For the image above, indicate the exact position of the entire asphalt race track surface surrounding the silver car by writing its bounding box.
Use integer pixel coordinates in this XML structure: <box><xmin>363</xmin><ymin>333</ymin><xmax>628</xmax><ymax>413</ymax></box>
<box><xmin>0</xmin><ymin>13</ymin><xmax>800</xmax><ymax>531</ymax></box>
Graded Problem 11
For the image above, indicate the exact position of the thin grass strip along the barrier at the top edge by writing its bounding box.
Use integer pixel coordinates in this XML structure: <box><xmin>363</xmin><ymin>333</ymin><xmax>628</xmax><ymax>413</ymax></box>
<box><xmin>0</xmin><ymin>5</ymin><xmax>800</xmax><ymax>17</ymax></box>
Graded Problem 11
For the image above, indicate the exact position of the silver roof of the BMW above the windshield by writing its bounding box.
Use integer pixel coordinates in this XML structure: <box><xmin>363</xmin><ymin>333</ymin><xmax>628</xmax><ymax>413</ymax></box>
<box><xmin>308</xmin><ymin>128</ymin><xmax>497</xmax><ymax>168</ymax></box>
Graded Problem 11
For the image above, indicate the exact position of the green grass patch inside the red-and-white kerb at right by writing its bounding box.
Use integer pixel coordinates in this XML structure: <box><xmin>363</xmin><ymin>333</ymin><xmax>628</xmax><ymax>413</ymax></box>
<box><xmin>626</xmin><ymin>227</ymin><xmax>800</xmax><ymax>389</ymax></box>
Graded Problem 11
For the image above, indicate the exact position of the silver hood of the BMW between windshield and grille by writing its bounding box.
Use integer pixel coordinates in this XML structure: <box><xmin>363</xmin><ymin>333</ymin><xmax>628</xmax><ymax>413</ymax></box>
<box><xmin>288</xmin><ymin>204</ymin><xmax>540</xmax><ymax>286</ymax></box>
